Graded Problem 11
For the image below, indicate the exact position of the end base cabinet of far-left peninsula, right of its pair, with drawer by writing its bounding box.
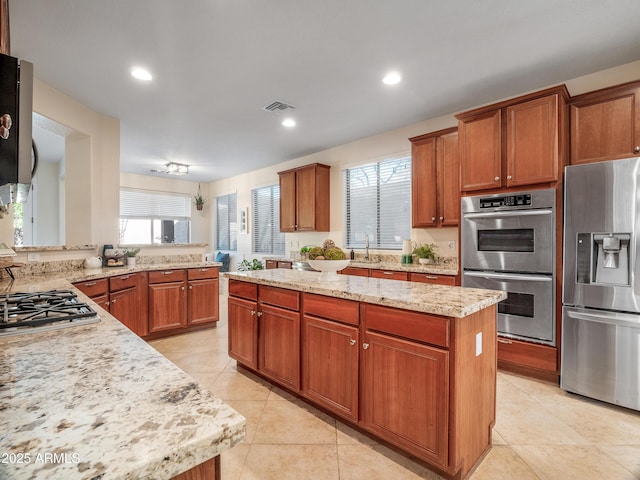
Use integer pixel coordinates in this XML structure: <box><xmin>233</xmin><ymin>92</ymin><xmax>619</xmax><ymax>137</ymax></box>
<box><xmin>187</xmin><ymin>267</ymin><xmax>220</xmax><ymax>325</ymax></box>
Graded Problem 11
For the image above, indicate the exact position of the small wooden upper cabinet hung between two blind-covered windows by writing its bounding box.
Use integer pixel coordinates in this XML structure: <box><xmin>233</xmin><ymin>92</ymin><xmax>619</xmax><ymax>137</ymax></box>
<box><xmin>278</xmin><ymin>163</ymin><xmax>331</xmax><ymax>232</ymax></box>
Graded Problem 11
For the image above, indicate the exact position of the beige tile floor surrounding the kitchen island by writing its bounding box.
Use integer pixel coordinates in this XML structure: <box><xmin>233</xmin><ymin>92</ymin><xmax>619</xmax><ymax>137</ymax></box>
<box><xmin>150</xmin><ymin>295</ymin><xmax>640</xmax><ymax>480</ymax></box>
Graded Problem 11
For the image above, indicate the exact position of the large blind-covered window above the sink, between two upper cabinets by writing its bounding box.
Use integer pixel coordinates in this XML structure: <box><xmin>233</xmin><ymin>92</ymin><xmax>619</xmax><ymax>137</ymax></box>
<box><xmin>344</xmin><ymin>157</ymin><xmax>411</xmax><ymax>250</ymax></box>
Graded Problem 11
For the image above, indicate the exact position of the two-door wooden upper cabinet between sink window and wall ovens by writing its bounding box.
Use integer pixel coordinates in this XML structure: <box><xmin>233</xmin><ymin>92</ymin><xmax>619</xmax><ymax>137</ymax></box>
<box><xmin>409</xmin><ymin>128</ymin><xmax>460</xmax><ymax>228</ymax></box>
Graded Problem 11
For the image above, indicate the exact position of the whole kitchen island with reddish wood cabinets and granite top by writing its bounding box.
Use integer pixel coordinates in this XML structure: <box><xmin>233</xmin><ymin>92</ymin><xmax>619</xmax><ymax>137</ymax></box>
<box><xmin>225</xmin><ymin>269</ymin><xmax>506</xmax><ymax>479</ymax></box>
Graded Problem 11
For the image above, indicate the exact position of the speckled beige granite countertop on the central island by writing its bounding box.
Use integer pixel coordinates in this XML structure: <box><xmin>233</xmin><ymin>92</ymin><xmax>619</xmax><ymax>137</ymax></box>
<box><xmin>222</xmin><ymin>268</ymin><xmax>507</xmax><ymax>318</ymax></box>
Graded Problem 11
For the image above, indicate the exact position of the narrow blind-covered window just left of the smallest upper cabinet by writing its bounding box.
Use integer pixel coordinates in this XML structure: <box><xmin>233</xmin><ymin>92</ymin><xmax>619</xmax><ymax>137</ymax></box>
<box><xmin>251</xmin><ymin>185</ymin><xmax>284</xmax><ymax>255</ymax></box>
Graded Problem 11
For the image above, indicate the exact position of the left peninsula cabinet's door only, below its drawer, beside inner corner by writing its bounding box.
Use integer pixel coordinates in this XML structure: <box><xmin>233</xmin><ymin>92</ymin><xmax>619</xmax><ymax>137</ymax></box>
<box><xmin>149</xmin><ymin>281</ymin><xmax>187</xmax><ymax>333</ymax></box>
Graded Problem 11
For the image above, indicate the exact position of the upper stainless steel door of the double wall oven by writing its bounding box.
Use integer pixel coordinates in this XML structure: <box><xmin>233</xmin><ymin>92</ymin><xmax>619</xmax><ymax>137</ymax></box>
<box><xmin>460</xmin><ymin>202</ymin><xmax>555</xmax><ymax>273</ymax></box>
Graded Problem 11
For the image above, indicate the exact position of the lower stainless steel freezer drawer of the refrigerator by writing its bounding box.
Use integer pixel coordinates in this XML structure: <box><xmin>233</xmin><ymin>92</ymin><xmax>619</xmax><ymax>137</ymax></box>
<box><xmin>560</xmin><ymin>307</ymin><xmax>640</xmax><ymax>410</ymax></box>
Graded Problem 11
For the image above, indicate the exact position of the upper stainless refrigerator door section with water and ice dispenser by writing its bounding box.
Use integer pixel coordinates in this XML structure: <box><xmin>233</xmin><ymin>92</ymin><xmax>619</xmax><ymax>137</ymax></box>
<box><xmin>563</xmin><ymin>158</ymin><xmax>640</xmax><ymax>313</ymax></box>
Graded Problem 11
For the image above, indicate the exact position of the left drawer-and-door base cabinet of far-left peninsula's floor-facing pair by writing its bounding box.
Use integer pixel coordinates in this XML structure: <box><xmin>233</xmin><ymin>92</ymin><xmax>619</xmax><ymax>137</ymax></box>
<box><xmin>149</xmin><ymin>270</ymin><xmax>187</xmax><ymax>333</ymax></box>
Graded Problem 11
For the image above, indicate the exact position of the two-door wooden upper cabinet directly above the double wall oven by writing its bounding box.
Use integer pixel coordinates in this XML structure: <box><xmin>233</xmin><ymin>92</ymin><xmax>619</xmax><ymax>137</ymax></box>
<box><xmin>456</xmin><ymin>85</ymin><xmax>569</xmax><ymax>192</ymax></box>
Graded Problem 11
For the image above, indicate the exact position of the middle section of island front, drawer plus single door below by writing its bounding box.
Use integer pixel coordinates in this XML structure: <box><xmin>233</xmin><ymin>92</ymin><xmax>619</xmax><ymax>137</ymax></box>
<box><xmin>301</xmin><ymin>294</ymin><xmax>360</xmax><ymax>422</ymax></box>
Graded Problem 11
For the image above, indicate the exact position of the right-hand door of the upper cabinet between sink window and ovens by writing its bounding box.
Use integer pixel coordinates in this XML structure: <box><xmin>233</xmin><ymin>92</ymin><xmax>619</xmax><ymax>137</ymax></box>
<box><xmin>436</xmin><ymin>132</ymin><xmax>460</xmax><ymax>227</ymax></box>
